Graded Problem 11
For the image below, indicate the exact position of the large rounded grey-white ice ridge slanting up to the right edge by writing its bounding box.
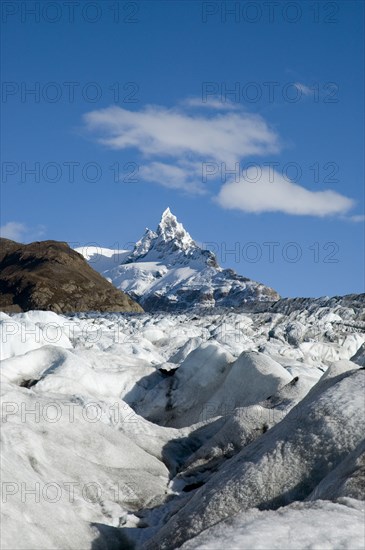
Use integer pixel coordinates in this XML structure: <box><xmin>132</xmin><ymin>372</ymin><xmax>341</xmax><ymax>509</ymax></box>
<box><xmin>145</xmin><ymin>369</ymin><xmax>365</xmax><ymax>550</ymax></box>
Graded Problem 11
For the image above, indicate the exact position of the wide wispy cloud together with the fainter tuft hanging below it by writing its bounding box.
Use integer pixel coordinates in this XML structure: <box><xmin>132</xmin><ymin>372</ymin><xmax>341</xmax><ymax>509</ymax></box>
<box><xmin>84</xmin><ymin>104</ymin><xmax>279</xmax><ymax>193</ymax></box>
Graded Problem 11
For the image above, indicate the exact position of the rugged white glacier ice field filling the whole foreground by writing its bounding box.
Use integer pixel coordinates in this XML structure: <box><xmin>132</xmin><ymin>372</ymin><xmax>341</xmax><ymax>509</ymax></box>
<box><xmin>0</xmin><ymin>296</ymin><xmax>365</xmax><ymax>550</ymax></box>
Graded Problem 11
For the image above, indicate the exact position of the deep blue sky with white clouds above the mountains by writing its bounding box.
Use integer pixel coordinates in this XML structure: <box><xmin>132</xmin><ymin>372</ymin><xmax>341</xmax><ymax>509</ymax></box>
<box><xmin>1</xmin><ymin>0</ymin><xmax>364</xmax><ymax>296</ymax></box>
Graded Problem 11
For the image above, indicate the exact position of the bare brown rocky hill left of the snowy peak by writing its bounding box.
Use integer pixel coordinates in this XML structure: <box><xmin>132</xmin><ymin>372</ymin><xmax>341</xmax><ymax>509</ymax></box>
<box><xmin>0</xmin><ymin>239</ymin><xmax>143</xmax><ymax>313</ymax></box>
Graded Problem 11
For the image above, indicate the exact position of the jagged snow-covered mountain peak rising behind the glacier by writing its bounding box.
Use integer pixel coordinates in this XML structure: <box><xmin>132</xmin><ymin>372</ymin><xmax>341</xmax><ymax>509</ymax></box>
<box><xmin>83</xmin><ymin>208</ymin><xmax>280</xmax><ymax>311</ymax></box>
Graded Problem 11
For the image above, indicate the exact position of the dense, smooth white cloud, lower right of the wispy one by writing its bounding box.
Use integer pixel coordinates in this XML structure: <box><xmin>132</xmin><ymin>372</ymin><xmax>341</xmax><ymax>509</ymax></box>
<box><xmin>215</xmin><ymin>168</ymin><xmax>354</xmax><ymax>217</ymax></box>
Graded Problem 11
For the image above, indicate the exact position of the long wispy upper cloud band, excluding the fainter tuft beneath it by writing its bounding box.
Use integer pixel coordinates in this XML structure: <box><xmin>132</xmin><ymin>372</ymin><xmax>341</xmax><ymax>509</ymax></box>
<box><xmin>85</xmin><ymin>106</ymin><xmax>279</xmax><ymax>162</ymax></box>
